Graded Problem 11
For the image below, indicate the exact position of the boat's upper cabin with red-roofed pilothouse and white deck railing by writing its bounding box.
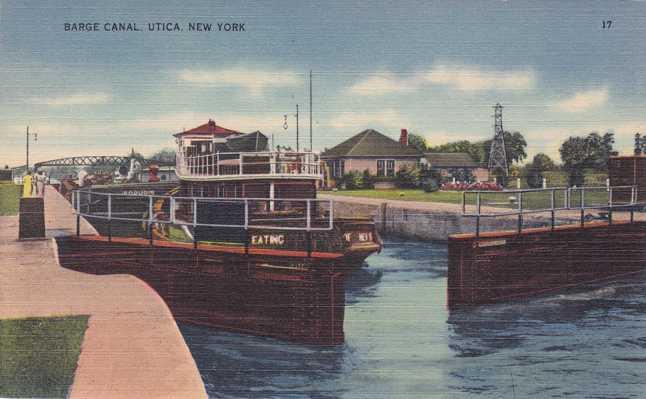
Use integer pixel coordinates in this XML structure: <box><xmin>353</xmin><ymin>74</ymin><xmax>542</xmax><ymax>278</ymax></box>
<box><xmin>174</xmin><ymin>120</ymin><xmax>323</xmax><ymax>208</ymax></box>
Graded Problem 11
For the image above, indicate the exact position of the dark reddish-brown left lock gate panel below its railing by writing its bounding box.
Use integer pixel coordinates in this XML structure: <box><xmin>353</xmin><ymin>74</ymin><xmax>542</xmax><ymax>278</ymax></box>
<box><xmin>58</xmin><ymin>236</ymin><xmax>345</xmax><ymax>345</ymax></box>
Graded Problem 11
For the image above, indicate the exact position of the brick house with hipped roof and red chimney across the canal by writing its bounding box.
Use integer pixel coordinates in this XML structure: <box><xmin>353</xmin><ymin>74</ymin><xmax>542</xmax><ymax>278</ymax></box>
<box><xmin>321</xmin><ymin>129</ymin><xmax>423</xmax><ymax>179</ymax></box>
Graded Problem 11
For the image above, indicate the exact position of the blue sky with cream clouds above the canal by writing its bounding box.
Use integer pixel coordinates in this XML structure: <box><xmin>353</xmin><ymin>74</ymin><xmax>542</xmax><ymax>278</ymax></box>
<box><xmin>0</xmin><ymin>0</ymin><xmax>646</xmax><ymax>166</ymax></box>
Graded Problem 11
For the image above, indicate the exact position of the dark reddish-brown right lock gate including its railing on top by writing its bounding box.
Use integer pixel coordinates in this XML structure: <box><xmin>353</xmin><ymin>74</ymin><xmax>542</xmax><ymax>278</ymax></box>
<box><xmin>447</xmin><ymin>186</ymin><xmax>646</xmax><ymax>307</ymax></box>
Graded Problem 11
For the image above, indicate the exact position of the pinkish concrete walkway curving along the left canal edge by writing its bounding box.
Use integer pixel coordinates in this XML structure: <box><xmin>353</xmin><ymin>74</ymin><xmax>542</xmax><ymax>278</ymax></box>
<box><xmin>0</xmin><ymin>187</ymin><xmax>207</xmax><ymax>398</ymax></box>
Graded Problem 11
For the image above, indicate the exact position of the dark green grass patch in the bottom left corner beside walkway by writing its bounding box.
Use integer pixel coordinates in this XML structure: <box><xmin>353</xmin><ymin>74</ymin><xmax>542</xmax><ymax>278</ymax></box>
<box><xmin>0</xmin><ymin>316</ymin><xmax>88</xmax><ymax>398</ymax></box>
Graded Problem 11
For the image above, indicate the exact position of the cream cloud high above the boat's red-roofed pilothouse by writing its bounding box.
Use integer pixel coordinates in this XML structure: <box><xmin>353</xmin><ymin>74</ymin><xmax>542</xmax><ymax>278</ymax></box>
<box><xmin>178</xmin><ymin>67</ymin><xmax>302</xmax><ymax>96</ymax></box>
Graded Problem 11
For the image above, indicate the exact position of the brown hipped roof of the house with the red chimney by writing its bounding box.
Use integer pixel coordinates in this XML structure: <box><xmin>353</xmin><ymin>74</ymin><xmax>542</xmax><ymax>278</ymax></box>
<box><xmin>321</xmin><ymin>129</ymin><xmax>422</xmax><ymax>158</ymax></box>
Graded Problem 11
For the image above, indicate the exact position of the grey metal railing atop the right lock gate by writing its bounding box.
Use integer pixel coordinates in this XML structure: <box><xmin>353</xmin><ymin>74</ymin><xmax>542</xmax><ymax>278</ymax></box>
<box><xmin>462</xmin><ymin>185</ymin><xmax>646</xmax><ymax>237</ymax></box>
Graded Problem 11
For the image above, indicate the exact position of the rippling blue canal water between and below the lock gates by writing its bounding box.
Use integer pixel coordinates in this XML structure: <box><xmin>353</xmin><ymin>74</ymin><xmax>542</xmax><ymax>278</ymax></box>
<box><xmin>180</xmin><ymin>240</ymin><xmax>646</xmax><ymax>399</ymax></box>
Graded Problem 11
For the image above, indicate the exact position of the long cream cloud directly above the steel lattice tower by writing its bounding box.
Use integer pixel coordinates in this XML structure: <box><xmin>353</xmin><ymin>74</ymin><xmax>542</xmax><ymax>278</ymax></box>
<box><xmin>424</xmin><ymin>64</ymin><xmax>536</xmax><ymax>91</ymax></box>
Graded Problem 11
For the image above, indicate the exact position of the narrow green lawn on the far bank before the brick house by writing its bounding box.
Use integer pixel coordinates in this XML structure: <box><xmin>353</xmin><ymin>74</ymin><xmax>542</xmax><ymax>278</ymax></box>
<box><xmin>331</xmin><ymin>189</ymin><xmax>625</xmax><ymax>209</ymax></box>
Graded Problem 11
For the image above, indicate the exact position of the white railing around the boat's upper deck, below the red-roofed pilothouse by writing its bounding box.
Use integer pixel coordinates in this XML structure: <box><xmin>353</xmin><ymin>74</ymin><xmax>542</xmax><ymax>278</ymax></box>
<box><xmin>176</xmin><ymin>147</ymin><xmax>323</xmax><ymax>179</ymax></box>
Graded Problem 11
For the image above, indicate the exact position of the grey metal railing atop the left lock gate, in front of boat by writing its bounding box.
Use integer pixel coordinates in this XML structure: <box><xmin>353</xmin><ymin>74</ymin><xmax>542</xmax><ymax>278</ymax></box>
<box><xmin>72</xmin><ymin>189</ymin><xmax>334</xmax><ymax>239</ymax></box>
